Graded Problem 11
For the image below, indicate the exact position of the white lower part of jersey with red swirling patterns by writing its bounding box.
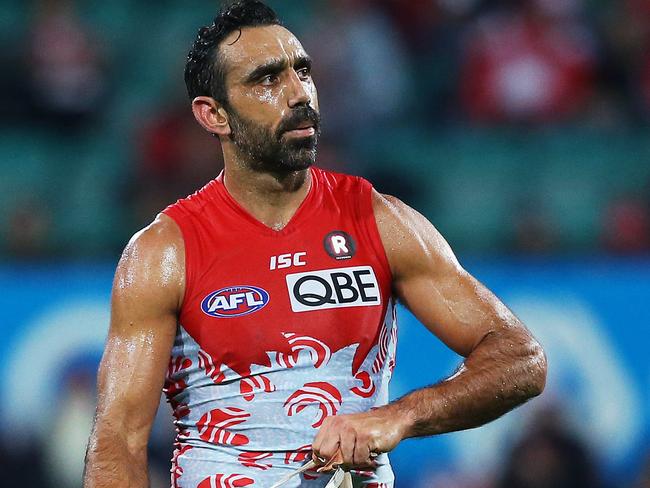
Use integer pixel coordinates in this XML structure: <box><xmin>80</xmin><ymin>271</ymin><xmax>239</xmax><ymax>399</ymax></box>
<box><xmin>168</xmin><ymin>300</ymin><xmax>396</xmax><ymax>488</ymax></box>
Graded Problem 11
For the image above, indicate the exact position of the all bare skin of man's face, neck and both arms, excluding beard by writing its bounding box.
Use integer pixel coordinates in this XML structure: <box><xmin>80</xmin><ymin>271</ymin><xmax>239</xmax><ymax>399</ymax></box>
<box><xmin>84</xmin><ymin>21</ymin><xmax>546</xmax><ymax>488</ymax></box>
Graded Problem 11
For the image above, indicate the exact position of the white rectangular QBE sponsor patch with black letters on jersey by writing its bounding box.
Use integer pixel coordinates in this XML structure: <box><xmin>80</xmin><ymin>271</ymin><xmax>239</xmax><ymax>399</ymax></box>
<box><xmin>287</xmin><ymin>266</ymin><xmax>381</xmax><ymax>312</ymax></box>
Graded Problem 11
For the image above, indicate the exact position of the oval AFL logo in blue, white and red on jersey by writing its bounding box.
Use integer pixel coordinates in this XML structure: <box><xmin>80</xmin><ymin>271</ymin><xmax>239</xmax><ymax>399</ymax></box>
<box><xmin>201</xmin><ymin>285</ymin><xmax>269</xmax><ymax>318</ymax></box>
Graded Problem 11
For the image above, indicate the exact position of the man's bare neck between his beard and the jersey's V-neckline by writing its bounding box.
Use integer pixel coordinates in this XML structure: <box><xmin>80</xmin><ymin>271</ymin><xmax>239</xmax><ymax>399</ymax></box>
<box><xmin>224</xmin><ymin>145</ymin><xmax>311</xmax><ymax>230</ymax></box>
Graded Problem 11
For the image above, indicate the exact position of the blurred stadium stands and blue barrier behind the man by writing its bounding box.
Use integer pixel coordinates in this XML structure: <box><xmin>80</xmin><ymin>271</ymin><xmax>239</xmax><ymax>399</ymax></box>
<box><xmin>0</xmin><ymin>0</ymin><xmax>650</xmax><ymax>488</ymax></box>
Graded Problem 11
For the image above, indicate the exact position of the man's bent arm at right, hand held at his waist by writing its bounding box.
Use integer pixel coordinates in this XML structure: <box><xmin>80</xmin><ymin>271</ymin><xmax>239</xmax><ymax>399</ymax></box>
<box><xmin>312</xmin><ymin>193</ymin><xmax>546</xmax><ymax>467</ymax></box>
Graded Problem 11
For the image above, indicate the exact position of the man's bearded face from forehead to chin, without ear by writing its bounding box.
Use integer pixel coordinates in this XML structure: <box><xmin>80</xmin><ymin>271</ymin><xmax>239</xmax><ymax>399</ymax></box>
<box><xmin>220</xmin><ymin>25</ymin><xmax>320</xmax><ymax>171</ymax></box>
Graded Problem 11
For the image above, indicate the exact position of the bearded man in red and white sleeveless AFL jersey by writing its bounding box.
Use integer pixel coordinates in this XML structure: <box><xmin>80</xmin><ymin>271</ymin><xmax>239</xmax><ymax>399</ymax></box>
<box><xmin>85</xmin><ymin>1</ymin><xmax>546</xmax><ymax>488</ymax></box>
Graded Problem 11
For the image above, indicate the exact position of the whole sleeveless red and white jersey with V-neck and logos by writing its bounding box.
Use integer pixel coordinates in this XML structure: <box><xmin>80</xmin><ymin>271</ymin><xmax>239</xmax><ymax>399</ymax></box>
<box><xmin>164</xmin><ymin>168</ymin><xmax>397</xmax><ymax>488</ymax></box>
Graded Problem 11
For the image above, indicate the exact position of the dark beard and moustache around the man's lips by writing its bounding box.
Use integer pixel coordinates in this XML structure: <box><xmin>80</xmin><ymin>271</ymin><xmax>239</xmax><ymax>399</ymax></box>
<box><xmin>229</xmin><ymin>105</ymin><xmax>320</xmax><ymax>172</ymax></box>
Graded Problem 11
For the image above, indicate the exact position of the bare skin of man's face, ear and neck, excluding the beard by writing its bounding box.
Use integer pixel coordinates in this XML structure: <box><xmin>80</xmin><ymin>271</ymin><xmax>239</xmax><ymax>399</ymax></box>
<box><xmin>192</xmin><ymin>25</ymin><xmax>319</xmax><ymax>230</ymax></box>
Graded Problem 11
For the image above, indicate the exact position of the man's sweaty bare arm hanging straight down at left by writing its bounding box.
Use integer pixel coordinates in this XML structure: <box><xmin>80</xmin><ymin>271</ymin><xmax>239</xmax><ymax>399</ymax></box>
<box><xmin>84</xmin><ymin>215</ymin><xmax>185</xmax><ymax>488</ymax></box>
